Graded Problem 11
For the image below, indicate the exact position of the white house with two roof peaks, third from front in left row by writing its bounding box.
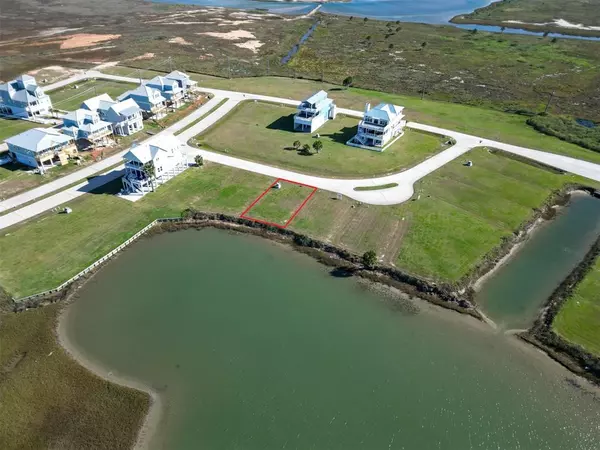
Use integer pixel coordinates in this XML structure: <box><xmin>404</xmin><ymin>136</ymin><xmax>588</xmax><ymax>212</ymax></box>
<box><xmin>81</xmin><ymin>94</ymin><xmax>144</xmax><ymax>136</ymax></box>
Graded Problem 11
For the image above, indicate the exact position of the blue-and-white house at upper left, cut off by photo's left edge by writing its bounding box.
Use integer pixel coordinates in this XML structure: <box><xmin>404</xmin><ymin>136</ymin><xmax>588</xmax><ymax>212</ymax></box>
<box><xmin>0</xmin><ymin>75</ymin><xmax>52</xmax><ymax>118</ymax></box>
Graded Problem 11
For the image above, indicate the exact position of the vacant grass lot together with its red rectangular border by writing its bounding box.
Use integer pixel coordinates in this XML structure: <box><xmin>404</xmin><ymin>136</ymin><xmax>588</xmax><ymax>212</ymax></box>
<box><xmin>240</xmin><ymin>178</ymin><xmax>317</xmax><ymax>228</ymax></box>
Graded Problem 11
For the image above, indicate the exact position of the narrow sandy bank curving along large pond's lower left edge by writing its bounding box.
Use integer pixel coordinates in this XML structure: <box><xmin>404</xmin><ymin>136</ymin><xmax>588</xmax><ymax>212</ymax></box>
<box><xmin>56</xmin><ymin>304</ymin><xmax>162</xmax><ymax>450</ymax></box>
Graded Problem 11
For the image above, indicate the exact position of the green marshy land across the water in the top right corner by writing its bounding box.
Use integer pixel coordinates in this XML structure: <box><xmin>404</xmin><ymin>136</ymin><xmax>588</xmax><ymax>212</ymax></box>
<box><xmin>452</xmin><ymin>0</ymin><xmax>600</xmax><ymax>36</ymax></box>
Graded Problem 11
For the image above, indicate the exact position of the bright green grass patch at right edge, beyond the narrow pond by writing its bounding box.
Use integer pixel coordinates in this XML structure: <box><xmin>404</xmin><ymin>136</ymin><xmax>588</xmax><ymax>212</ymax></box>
<box><xmin>552</xmin><ymin>259</ymin><xmax>600</xmax><ymax>356</ymax></box>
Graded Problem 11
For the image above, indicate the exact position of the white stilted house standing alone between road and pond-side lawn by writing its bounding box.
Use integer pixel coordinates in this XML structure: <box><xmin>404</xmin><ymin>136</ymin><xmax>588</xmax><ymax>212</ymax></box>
<box><xmin>122</xmin><ymin>134</ymin><xmax>188</xmax><ymax>195</ymax></box>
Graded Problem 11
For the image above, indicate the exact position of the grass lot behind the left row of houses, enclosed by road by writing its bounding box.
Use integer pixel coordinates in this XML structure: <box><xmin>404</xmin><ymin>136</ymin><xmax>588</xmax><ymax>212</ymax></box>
<box><xmin>49</xmin><ymin>80</ymin><xmax>136</xmax><ymax>111</ymax></box>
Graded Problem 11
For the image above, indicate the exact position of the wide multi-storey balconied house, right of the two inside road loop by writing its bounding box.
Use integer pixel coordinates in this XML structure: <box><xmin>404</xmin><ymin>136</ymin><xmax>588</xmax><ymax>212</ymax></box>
<box><xmin>346</xmin><ymin>103</ymin><xmax>406</xmax><ymax>152</ymax></box>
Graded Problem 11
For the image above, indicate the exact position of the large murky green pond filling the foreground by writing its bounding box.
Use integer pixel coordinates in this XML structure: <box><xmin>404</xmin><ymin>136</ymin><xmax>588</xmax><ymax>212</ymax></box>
<box><xmin>62</xmin><ymin>229</ymin><xmax>600</xmax><ymax>450</ymax></box>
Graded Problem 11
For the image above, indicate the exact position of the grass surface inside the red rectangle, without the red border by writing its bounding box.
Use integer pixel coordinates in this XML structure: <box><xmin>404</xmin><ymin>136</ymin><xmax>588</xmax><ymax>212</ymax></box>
<box><xmin>246</xmin><ymin>181</ymin><xmax>313</xmax><ymax>226</ymax></box>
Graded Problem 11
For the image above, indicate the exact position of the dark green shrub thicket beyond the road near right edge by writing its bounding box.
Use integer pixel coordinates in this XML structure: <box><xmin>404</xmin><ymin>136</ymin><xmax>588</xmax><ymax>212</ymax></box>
<box><xmin>527</xmin><ymin>115</ymin><xmax>600</xmax><ymax>152</ymax></box>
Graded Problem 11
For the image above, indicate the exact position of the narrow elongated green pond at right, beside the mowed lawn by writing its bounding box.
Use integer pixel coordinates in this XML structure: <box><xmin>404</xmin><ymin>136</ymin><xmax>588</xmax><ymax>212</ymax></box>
<box><xmin>476</xmin><ymin>193</ymin><xmax>600</xmax><ymax>329</ymax></box>
